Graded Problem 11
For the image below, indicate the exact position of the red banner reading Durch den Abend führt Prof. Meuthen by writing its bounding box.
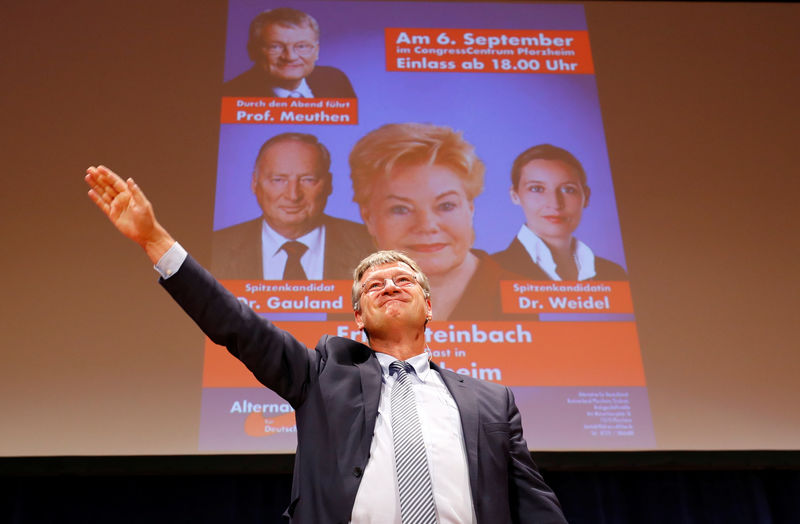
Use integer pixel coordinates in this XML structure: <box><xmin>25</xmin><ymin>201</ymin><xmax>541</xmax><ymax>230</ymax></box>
<box><xmin>220</xmin><ymin>96</ymin><xmax>358</xmax><ymax>125</ymax></box>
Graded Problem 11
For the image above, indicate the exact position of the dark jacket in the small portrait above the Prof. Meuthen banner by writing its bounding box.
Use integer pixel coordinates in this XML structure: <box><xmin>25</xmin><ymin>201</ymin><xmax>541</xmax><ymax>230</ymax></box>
<box><xmin>222</xmin><ymin>66</ymin><xmax>356</xmax><ymax>98</ymax></box>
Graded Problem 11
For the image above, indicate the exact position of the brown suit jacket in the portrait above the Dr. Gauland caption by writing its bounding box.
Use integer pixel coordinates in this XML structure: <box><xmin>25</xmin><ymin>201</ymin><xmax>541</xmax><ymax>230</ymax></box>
<box><xmin>211</xmin><ymin>215</ymin><xmax>375</xmax><ymax>280</ymax></box>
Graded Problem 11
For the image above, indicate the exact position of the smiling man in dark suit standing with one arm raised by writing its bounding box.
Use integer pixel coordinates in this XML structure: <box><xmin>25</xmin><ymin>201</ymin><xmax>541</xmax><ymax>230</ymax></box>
<box><xmin>86</xmin><ymin>166</ymin><xmax>566</xmax><ymax>524</ymax></box>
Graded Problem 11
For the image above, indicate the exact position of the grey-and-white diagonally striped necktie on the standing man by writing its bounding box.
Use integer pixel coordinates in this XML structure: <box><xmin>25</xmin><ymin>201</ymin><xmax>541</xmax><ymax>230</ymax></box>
<box><xmin>389</xmin><ymin>360</ymin><xmax>436</xmax><ymax>524</ymax></box>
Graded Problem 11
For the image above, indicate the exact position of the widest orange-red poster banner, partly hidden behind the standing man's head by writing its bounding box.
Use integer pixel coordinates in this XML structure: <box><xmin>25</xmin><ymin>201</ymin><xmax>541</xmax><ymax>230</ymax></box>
<box><xmin>203</xmin><ymin>322</ymin><xmax>645</xmax><ymax>387</ymax></box>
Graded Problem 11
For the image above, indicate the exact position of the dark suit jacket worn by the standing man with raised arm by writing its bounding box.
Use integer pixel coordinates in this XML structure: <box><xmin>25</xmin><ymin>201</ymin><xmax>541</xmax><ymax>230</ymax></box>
<box><xmin>161</xmin><ymin>257</ymin><xmax>566</xmax><ymax>524</ymax></box>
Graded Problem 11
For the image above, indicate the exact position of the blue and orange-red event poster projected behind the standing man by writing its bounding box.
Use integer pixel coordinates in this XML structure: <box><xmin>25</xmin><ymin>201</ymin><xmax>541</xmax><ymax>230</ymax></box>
<box><xmin>199</xmin><ymin>0</ymin><xmax>655</xmax><ymax>453</ymax></box>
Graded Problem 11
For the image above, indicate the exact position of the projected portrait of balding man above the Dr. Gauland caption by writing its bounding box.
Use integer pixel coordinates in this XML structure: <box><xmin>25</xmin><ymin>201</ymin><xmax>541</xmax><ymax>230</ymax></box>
<box><xmin>212</xmin><ymin>133</ymin><xmax>373</xmax><ymax>280</ymax></box>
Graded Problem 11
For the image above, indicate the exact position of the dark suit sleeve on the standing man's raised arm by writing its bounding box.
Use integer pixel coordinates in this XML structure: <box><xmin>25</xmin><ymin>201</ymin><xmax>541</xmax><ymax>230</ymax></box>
<box><xmin>159</xmin><ymin>256</ymin><xmax>321</xmax><ymax>408</ymax></box>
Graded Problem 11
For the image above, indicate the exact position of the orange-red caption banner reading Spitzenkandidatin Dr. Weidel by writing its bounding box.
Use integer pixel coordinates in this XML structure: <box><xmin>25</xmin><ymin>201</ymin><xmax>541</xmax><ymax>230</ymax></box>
<box><xmin>500</xmin><ymin>280</ymin><xmax>633</xmax><ymax>314</ymax></box>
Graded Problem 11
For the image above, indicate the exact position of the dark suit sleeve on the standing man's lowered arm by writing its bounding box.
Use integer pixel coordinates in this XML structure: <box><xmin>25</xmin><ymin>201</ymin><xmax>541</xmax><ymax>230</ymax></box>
<box><xmin>506</xmin><ymin>388</ymin><xmax>567</xmax><ymax>524</ymax></box>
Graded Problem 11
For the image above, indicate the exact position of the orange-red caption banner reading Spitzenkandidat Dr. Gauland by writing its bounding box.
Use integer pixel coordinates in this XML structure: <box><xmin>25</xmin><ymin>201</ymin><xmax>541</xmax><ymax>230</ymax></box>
<box><xmin>221</xmin><ymin>280</ymin><xmax>353</xmax><ymax>315</ymax></box>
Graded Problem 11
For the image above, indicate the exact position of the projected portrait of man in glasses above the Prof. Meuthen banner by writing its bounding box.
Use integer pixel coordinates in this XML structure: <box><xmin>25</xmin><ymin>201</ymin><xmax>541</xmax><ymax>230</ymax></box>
<box><xmin>223</xmin><ymin>7</ymin><xmax>356</xmax><ymax>98</ymax></box>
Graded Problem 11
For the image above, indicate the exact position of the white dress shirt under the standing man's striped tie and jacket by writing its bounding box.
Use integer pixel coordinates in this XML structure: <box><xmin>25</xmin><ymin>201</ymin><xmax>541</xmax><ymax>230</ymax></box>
<box><xmin>350</xmin><ymin>352</ymin><xmax>476</xmax><ymax>524</ymax></box>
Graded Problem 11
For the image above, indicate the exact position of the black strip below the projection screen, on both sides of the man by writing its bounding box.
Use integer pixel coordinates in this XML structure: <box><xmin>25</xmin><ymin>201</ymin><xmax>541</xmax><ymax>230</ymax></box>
<box><xmin>0</xmin><ymin>452</ymin><xmax>800</xmax><ymax>524</ymax></box>
